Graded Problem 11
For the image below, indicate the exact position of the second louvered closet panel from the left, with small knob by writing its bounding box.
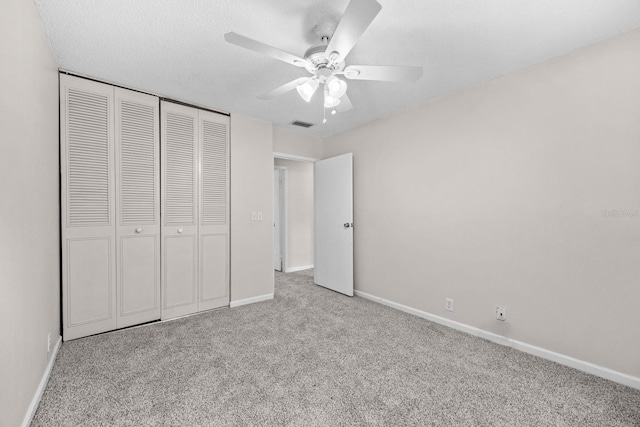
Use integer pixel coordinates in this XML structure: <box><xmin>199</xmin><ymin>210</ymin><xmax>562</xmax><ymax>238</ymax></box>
<box><xmin>115</xmin><ymin>88</ymin><xmax>160</xmax><ymax>328</ymax></box>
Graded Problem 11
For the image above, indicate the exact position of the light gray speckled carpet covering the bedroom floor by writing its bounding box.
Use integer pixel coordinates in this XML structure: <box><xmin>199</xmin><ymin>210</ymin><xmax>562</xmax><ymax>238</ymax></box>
<box><xmin>32</xmin><ymin>271</ymin><xmax>640</xmax><ymax>427</ymax></box>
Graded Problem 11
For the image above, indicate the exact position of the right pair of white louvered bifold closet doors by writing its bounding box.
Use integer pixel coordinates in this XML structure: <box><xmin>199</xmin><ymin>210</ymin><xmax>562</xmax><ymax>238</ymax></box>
<box><xmin>161</xmin><ymin>102</ymin><xmax>229</xmax><ymax>319</ymax></box>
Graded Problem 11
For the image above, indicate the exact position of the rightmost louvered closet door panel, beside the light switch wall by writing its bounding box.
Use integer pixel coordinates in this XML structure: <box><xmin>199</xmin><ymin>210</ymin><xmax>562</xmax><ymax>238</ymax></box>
<box><xmin>198</xmin><ymin>111</ymin><xmax>229</xmax><ymax>310</ymax></box>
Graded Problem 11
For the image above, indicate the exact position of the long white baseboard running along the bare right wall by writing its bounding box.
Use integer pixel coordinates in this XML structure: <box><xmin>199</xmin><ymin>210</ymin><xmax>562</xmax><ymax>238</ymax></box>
<box><xmin>355</xmin><ymin>291</ymin><xmax>640</xmax><ymax>390</ymax></box>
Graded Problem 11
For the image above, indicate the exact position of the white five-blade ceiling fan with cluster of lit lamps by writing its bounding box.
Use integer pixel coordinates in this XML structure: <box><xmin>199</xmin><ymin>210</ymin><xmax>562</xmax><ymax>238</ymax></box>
<box><xmin>224</xmin><ymin>0</ymin><xmax>422</xmax><ymax>123</ymax></box>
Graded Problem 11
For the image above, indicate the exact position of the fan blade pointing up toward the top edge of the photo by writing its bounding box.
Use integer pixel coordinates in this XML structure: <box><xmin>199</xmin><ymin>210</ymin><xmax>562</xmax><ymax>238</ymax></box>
<box><xmin>325</xmin><ymin>0</ymin><xmax>382</xmax><ymax>63</ymax></box>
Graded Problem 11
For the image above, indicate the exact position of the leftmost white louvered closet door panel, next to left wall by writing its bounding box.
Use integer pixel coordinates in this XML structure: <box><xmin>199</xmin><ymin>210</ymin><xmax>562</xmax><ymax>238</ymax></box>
<box><xmin>60</xmin><ymin>75</ymin><xmax>116</xmax><ymax>340</ymax></box>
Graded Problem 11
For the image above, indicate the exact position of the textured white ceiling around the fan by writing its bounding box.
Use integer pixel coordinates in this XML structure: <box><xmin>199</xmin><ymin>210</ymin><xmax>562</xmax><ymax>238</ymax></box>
<box><xmin>35</xmin><ymin>0</ymin><xmax>640</xmax><ymax>137</ymax></box>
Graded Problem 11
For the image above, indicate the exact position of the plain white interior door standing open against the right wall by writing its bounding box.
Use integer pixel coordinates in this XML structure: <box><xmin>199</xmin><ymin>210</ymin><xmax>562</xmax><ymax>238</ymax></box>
<box><xmin>313</xmin><ymin>153</ymin><xmax>353</xmax><ymax>296</ymax></box>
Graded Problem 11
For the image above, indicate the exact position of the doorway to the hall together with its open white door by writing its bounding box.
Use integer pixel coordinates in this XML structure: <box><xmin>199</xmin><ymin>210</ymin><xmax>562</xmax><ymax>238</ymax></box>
<box><xmin>273</xmin><ymin>153</ymin><xmax>354</xmax><ymax>296</ymax></box>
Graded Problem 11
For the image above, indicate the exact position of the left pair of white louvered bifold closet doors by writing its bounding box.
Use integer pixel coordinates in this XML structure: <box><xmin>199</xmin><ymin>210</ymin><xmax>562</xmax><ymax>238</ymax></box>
<box><xmin>60</xmin><ymin>75</ymin><xmax>160</xmax><ymax>340</ymax></box>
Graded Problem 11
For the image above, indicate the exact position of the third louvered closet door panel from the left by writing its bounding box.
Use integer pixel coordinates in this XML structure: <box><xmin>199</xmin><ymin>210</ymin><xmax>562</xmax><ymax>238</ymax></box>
<box><xmin>161</xmin><ymin>101</ymin><xmax>198</xmax><ymax>319</ymax></box>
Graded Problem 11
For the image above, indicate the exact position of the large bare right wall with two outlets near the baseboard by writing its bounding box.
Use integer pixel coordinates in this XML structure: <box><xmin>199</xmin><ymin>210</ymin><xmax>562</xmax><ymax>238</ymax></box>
<box><xmin>324</xmin><ymin>30</ymin><xmax>640</xmax><ymax>377</ymax></box>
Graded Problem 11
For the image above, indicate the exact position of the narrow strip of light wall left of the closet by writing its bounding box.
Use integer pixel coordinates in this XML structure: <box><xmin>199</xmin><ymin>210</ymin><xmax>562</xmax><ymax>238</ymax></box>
<box><xmin>0</xmin><ymin>0</ymin><xmax>60</xmax><ymax>426</ymax></box>
